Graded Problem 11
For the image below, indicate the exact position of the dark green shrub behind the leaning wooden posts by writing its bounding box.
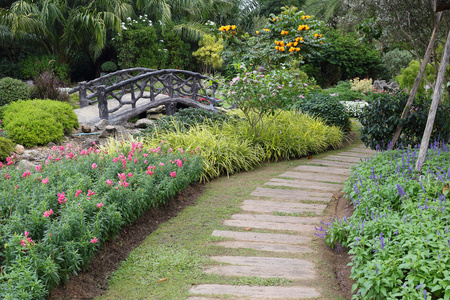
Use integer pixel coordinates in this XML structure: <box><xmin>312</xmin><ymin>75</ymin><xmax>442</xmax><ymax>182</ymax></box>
<box><xmin>359</xmin><ymin>91</ymin><xmax>450</xmax><ymax>149</ymax></box>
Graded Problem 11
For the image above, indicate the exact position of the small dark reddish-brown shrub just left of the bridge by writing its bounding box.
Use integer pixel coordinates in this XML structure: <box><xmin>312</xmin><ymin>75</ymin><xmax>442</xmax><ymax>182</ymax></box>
<box><xmin>31</xmin><ymin>71</ymin><xmax>69</xmax><ymax>102</ymax></box>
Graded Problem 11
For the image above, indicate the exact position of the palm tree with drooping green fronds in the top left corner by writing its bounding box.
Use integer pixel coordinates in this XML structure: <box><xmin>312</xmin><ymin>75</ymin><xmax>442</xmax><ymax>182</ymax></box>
<box><xmin>0</xmin><ymin>0</ymin><xmax>134</xmax><ymax>63</ymax></box>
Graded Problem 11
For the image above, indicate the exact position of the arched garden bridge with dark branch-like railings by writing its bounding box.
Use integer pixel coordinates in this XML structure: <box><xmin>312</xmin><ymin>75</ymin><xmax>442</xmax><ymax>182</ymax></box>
<box><xmin>69</xmin><ymin>68</ymin><xmax>220</xmax><ymax>121</ymax></box>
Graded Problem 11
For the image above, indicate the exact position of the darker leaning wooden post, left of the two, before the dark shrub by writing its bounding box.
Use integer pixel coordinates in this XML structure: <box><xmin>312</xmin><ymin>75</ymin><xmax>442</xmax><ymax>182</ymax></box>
<box><xmin>389</xmin><ymin>12</ymin><xmax>443</xmax><ymax>150</ymax></box>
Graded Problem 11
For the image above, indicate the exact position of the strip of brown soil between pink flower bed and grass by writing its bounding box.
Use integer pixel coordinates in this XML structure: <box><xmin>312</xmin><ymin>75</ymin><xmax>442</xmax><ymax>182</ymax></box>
<box><xmin>50</xmin><ymin>183</ymin><xmax>205</xmax><ymax>299</ymax></box>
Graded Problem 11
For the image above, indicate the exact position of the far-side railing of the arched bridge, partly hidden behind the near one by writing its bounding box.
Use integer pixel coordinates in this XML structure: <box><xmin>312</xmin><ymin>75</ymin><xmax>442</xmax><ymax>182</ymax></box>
<box><xmin>68</xmin><ymin>68</ymin><xmax>156</xmax><ymax>108</ymax></box>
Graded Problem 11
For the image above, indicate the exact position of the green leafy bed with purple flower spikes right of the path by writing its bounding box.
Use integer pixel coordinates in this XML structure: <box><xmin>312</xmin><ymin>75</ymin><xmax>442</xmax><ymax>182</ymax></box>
<box><xmin>325</xmin><ymin>144</ymin><xmax>450</xmax><ymax>299</ymax></box>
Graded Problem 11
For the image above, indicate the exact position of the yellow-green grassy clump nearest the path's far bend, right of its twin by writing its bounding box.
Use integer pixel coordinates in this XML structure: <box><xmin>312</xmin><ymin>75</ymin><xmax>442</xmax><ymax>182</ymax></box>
<box><xmin>241</xmin><ymin>111</ymin><xmax>344</xmax><ymax>161</ymax></box>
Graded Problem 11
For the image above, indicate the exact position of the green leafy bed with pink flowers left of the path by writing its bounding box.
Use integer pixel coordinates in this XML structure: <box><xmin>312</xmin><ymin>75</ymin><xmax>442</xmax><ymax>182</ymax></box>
<box><xmin>0</xmin><ymin>143</ymin><xmax>201</xmax><ymax>299</ymax></box>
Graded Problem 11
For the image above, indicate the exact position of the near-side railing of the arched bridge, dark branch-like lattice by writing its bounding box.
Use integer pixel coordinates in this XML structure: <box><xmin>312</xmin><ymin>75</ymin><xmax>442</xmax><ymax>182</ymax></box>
<box><xmin>69</xmin><ymin>69</ymin><xmax>220</xmax><ymax>119</ymax></box>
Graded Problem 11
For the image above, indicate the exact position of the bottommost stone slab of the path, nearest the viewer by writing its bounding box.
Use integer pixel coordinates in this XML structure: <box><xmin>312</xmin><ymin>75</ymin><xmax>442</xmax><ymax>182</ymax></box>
<box><xmin>189</xmin><ymin>284</ymin><xmax>320</xmax><ymax>299</ymax></box>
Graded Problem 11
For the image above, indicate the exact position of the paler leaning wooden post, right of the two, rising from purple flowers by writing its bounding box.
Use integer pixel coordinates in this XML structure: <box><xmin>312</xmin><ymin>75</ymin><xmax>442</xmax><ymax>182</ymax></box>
<box><xmin>415</xmin><ymin>32</ymin><xmax>450</xmax><ymax>171</ymax></box>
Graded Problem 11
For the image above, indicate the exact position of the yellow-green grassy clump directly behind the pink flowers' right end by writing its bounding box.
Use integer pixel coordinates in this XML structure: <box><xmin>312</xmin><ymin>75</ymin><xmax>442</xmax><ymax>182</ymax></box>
<box><xmin>144</xmin><ymin>121</ymin><xmax>264</xmax><ymax>182</ymax></box>
